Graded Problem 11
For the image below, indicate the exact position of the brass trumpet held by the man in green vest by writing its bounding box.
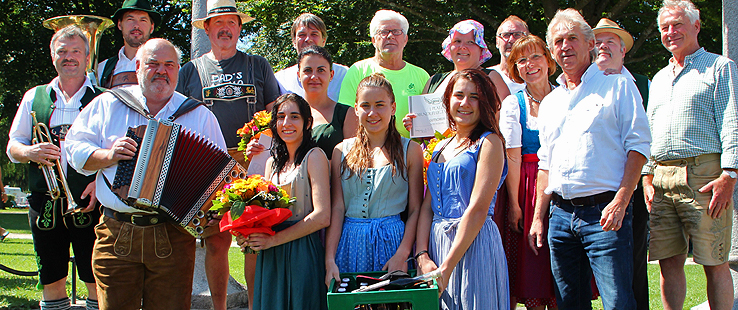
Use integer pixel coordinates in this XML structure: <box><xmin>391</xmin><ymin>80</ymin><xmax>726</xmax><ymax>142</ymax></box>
<box><xmin>31</xmin><ymin>111</ymin><xmax>77</xmax><ymax>214</ymax></box>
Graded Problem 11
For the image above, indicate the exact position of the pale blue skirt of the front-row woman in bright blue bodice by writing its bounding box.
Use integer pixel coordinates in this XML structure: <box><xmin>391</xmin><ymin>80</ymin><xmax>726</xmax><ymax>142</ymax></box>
<box><xmin>428</xmin><ymin>216</ymin><xmax>510</xmax><ymax>310</ymax></box>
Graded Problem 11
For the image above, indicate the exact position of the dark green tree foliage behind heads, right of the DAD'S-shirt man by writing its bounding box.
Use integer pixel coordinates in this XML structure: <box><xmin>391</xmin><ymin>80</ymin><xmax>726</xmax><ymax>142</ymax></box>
<box><xmin>243</xmin><ymin>0</ymin><xmax>721</xmax><ymax>77</ymax></box>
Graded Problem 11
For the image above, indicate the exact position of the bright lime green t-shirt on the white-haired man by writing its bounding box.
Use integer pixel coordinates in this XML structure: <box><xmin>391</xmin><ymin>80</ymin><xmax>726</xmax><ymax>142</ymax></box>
<box><xmin>338</xmin><ymin>58</ymin><xmax>430</xmax><ymax>137</ymax></box>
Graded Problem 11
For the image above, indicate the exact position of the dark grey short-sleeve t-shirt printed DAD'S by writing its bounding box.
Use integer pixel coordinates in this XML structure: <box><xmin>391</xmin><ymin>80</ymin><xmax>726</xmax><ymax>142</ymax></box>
<box><xmin>177</xmin><ymin>51</ymin><xmax>279</xmax><ymax>148</ymax></box>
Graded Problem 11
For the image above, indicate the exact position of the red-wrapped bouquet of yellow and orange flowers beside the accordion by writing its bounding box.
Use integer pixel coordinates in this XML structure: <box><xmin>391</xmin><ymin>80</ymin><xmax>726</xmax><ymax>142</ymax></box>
<box><xmin>210</xmin><ymin>174</ymin><xmax>295</xmax><ymax>252</ymax></box>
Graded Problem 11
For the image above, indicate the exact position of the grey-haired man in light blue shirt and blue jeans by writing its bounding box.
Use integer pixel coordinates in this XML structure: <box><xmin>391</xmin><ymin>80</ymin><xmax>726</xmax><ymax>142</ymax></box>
<box><xmin>528</xmin><ymin>9</ymin><xmax>651</xmax><ymax>309</ymax></box>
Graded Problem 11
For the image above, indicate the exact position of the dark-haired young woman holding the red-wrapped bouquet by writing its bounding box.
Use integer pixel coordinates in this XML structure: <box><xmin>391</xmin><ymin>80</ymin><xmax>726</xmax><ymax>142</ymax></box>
<box><xmin>236</xmin><ymin>94</ymin><xmax>331</xmax><ymax>310</ymax></box>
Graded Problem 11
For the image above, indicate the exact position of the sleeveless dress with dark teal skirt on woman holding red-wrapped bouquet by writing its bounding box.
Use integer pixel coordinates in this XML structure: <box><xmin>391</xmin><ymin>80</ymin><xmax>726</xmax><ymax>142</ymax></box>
<box><xmin>249</xmin><ymin>148</ymin><xmax>328</xmax><ymax>310</ymax></box>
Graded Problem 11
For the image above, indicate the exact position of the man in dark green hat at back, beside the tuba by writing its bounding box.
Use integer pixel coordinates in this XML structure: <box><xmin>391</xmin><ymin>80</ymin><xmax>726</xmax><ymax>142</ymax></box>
<box><xmin>97</xmin><ymin>0</ymin><xmax>161</xmax><ymax>88</ymax></box>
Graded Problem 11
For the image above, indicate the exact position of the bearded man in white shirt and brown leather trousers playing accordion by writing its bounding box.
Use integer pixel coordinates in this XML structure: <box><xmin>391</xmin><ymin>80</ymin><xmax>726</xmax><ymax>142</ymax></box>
<box><xmin>65</xmin><ymin>39</ymin><xmax>225</xmax><ymax>309</ymax></box>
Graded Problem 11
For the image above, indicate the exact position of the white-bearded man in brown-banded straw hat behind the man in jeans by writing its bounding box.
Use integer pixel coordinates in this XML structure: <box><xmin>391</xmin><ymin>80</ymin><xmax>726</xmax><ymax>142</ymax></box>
<box><xmin>592</xmin><ymin>18</ymin><xmax>651</xmax><ymax>310</ymax></box>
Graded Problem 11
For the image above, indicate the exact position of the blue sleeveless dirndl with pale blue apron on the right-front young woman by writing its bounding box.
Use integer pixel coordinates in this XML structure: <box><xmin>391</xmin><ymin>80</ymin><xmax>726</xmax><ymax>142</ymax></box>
<box><xmin>428</xmin><ymin>132</ymin><xmax>510</xmax><ymax>310</ymax></box>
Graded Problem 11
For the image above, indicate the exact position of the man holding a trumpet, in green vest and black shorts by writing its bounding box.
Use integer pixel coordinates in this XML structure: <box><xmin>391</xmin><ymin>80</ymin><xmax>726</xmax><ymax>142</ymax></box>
<box><xmin>6</xmin><ymin>26</ymin><xmax>100</xmax><ymax>310</ymax></box>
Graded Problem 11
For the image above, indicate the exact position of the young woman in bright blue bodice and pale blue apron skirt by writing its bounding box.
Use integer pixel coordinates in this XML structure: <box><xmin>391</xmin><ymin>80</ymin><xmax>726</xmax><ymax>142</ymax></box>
<box><xmin>415</xmin><ymin>69</ymin><xmax>510</xmax><ymax>309</ymax></box>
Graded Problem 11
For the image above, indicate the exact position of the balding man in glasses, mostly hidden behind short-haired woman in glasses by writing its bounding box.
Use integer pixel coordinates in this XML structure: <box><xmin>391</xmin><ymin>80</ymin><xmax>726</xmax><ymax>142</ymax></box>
<box><xmin>489</xmin><ymin>15</ymin><xmax>530</xmax><ymax>94</ymax></box>
